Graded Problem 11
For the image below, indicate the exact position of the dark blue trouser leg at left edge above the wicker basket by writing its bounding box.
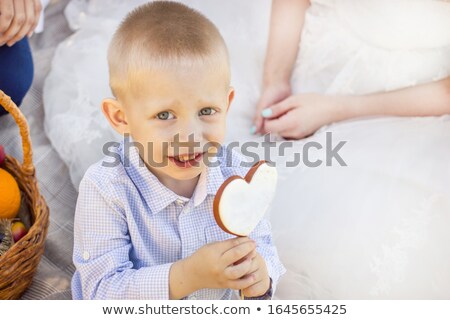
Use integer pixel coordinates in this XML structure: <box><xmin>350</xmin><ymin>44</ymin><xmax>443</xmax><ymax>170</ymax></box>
<box><xmin>0</xmin><ymin>37</ymin><xmax>34</xmax><ymax>116</ymax></box>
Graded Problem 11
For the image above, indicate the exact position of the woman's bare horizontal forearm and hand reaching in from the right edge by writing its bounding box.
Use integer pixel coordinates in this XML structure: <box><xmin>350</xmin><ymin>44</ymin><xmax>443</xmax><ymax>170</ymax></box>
<box><xmin>264</xmin><ymin>77</ymin><xmax>450</xmax><ymax>139</ymax></box>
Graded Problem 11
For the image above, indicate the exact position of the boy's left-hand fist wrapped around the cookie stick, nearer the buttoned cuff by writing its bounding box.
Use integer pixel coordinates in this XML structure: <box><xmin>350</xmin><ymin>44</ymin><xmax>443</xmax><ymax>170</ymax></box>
<box><xmin>187</xmin><ymin>237</ymin><xmax>259</xmax><ymax>290</ymax></box>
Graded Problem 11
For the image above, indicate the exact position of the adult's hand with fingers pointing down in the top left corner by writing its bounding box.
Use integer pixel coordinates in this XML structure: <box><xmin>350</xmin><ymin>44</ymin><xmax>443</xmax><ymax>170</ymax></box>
<box><xmin>0</xmin><ymin>0</ymin><xmax>42</xmax><ymax>47</ymax></box>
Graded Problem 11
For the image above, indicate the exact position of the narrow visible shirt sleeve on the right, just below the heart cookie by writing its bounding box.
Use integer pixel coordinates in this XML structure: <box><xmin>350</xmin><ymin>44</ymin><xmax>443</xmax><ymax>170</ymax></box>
<box><xmin>249</xmin><ymin>219</ymin><xmax>286</xmax><ymax>295</ymax></box>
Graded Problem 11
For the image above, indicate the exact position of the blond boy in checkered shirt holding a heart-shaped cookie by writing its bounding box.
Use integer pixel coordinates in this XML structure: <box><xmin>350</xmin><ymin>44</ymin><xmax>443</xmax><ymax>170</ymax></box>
<box><xmin>72</xmin><ymin>1</ymin><xmax>284</xmax><ymax>299</ymax></box>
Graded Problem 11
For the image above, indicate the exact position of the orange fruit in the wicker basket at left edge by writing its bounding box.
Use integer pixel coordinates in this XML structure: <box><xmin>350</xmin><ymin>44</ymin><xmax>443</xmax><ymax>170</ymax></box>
<box><xmin>0</xmin><ymin>168</ymin><xmax>20</xmax><ymax>219</ymax></box>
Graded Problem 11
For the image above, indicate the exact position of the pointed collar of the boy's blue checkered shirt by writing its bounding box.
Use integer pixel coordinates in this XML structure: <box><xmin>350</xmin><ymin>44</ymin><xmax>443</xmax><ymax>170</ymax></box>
<box><xmin>119</xmin><ymin>137</ymin><xmax>225</xmax><ymax>213</ymax></box>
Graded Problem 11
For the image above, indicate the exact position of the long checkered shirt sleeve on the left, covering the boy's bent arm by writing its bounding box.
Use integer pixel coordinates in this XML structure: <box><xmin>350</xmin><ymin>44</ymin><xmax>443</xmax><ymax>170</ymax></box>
<box><xmin>73</xmin><ymin>177</ymin><xmax>172</xmax><ymax>300</ymax></box>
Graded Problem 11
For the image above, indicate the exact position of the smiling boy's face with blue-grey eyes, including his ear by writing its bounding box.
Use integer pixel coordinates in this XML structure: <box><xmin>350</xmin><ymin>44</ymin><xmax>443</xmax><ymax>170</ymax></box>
<box><xmin>103</xmin><ymin>66</ymin><xmax>234</xmax><ymax>180</ymax></box>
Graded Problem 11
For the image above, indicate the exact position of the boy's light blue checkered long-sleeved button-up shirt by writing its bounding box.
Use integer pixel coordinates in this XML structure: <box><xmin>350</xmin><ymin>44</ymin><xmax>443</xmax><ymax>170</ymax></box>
<box><xmin>72</xmin><ymin>142</ymin><xmax>285</xmax><ymax>300</ymax></box>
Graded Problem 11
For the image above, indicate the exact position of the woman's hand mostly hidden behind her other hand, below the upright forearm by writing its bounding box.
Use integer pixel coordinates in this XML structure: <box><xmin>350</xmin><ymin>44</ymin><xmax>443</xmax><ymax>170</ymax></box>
<box><xmin>250</xmin><ymin>82</ymin><xmax>291</xmax><ymax>133</ymax></box>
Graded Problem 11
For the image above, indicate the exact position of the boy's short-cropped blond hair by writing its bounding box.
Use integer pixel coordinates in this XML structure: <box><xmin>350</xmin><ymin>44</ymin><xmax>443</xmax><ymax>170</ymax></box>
<box><xmin>108</xmin><ymin>1</ymin><xmax>230</xmax><ymax>97</ymax></box>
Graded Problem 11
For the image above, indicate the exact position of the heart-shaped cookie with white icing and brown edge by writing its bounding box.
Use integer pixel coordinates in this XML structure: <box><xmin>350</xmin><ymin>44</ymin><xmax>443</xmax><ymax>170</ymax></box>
<box><xmin>213</xmin><ymin>160</ymin><xmax>277</xmax><ymax>236</ymax></box>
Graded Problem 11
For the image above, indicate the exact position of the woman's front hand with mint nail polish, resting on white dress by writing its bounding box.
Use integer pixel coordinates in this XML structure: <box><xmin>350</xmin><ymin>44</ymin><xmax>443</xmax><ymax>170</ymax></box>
<box><xmin>262</xmin><ymin>94</ymin><xmax>345</xmax><ymax>139</ymax></box>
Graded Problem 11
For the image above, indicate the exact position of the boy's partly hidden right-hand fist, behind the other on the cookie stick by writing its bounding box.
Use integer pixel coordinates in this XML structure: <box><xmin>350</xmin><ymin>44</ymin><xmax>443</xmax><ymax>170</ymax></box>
<box><xmin>242</xmin><ymin>253</ymin><xmax>270</xmax><ymax>297</ymax></box>
